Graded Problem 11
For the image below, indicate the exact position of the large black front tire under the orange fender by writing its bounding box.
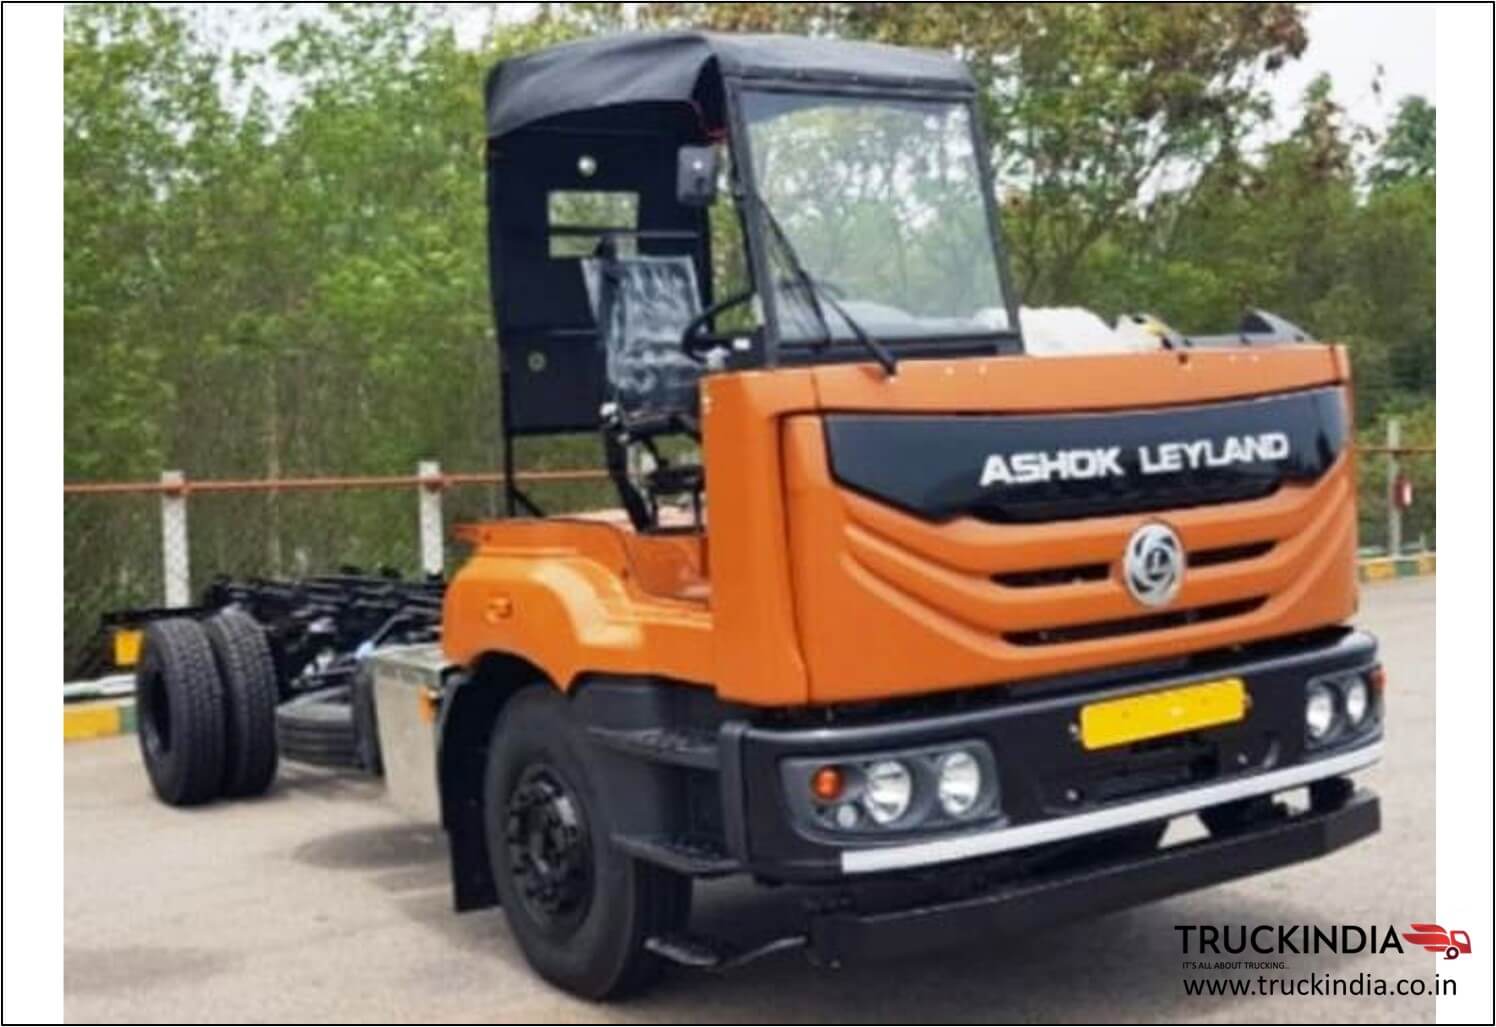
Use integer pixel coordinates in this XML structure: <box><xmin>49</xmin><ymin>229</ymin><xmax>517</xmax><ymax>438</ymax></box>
<box><xmin>483</xmin><ymin>684</ymin><xmax>691</xmax><ymax>999</ymax></box>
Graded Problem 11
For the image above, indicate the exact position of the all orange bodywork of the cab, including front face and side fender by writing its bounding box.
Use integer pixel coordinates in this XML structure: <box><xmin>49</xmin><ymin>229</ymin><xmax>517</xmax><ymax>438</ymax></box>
<box><xmin>444</xmin><ymin>346</ymin><xmax>1355</xmax><ymax>705</ymax></box>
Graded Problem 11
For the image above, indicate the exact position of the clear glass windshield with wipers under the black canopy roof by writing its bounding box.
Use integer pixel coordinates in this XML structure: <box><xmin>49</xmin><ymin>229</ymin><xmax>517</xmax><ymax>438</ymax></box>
<box><xmin>744</xmin><ymin>91</ymin><xmax>1008</xmax><ymax>343</ymax></box>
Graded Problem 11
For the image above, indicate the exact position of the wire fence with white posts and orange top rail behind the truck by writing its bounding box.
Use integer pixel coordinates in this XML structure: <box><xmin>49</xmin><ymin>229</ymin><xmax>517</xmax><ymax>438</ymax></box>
<box><xmin>63</xmin><ymin>440</ymin><xmax>1436</xmax><ymax>677</ymax></box>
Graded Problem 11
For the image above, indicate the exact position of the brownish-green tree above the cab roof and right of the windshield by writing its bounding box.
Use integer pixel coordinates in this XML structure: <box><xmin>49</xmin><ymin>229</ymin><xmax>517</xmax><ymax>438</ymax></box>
<box><xmin>613</xmin><ymin>3</ymin><xmax>1308</xmax><ymax>304</ymax></box>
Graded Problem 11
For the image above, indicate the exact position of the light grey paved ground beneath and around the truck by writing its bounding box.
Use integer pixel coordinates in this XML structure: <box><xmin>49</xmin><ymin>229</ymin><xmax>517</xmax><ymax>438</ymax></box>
<box><xmin>66</xmin><ymin>579</ymin><xmax>1444</xmax><ymax>1024</ymax></box>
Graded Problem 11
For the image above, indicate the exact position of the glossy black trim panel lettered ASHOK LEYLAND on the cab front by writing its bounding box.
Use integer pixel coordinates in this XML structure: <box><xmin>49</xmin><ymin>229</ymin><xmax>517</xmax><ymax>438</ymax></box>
<box><xmin>826</xmin><ymin>386</ymin><xmax>1348</xmax><ymax>522</ymax></box>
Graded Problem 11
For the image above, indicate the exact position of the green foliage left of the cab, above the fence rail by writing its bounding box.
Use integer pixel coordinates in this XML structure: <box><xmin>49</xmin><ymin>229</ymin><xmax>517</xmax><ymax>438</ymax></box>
<box><xmin>64</xmin><ymin>6</ymin><xmax>586</xmax><ymax>491</ymax></box>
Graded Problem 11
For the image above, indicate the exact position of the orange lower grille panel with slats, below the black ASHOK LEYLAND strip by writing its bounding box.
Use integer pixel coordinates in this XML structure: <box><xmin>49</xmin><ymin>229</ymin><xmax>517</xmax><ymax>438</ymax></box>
<box><xmin>785</xmin><ymin>418</ymin><xmax>1355</xmax><ymax>702</ymax></box>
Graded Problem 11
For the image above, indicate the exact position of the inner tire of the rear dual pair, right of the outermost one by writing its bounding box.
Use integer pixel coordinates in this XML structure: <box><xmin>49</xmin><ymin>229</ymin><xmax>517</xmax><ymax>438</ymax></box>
<box><xmin>203</xmin><ymin>608</ymin><xmax>280</xmax><ymax>798</ymax></box>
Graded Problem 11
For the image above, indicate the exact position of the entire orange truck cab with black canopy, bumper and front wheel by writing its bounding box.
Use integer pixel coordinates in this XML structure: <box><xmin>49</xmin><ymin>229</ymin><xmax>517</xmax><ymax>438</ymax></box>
<box><xmin>437</xmin><ymin>33</ymin><xmax>1384</xmax><ymax>997</ymax></box>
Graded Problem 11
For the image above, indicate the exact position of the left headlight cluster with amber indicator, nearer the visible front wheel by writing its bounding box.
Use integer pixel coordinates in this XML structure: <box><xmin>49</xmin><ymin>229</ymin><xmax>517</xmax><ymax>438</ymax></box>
<box><xmin>784</xmin><ymin>741</ymin><xmax>998</xmax><ymax>834</ymax></box>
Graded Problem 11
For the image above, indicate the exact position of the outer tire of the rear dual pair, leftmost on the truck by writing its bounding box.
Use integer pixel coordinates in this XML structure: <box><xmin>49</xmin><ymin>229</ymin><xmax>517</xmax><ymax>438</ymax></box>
<box><xmin>135</xmin><ymin>618</ymin><xmax>223</xmax><ymax>805</ymax></box>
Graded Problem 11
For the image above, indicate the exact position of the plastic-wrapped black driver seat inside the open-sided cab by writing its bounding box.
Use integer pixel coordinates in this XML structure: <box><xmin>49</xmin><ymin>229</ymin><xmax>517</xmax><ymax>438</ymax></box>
<box><xmin>582</xmin><ymin>237</ymin><xmax>706</xmax><ymax>531</ymax></box>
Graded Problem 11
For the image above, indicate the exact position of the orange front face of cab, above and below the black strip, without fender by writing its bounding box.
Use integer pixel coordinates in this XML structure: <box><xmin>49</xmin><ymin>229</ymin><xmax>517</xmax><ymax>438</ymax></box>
<box><xmin>782</xmin><ymin>347</ymin><xmax>1355</xmax><ymax>704</ymax></box>
